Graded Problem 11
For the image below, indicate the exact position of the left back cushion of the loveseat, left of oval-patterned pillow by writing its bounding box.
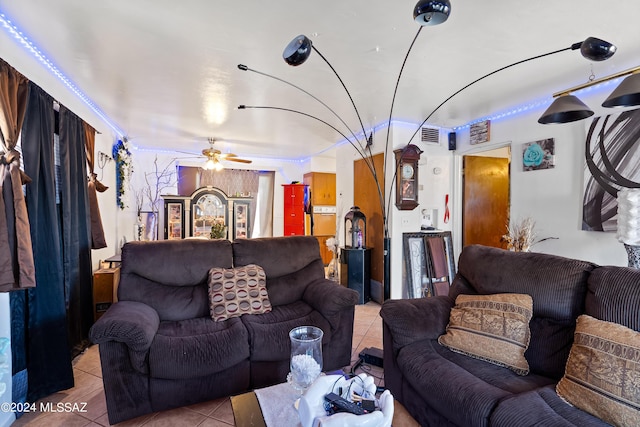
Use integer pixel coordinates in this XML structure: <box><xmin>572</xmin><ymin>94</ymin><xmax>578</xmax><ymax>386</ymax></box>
<box><xmin>118</xmin><ymin>240</ymin><xmax>233</xmax><ymax>321</ymax></box>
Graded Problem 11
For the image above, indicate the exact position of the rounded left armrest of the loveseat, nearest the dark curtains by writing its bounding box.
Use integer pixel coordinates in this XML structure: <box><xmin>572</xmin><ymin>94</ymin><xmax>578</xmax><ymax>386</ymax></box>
<box><xmin>89</xmin><ymin>301</ymin><xmax>160</xmax><ymax>352</ymax></box>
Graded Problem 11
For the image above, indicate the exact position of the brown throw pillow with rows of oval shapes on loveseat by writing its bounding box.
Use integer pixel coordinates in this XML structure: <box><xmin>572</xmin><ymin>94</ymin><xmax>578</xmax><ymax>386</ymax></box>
<box><xmin>209</xmin><ymin>264</ymin><xmax>271</xmax><ymax>322</ymax></box>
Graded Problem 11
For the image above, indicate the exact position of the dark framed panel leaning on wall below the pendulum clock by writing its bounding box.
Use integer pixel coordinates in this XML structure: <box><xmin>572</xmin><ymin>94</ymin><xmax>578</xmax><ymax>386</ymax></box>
<box><xmin>402</xmin><ymin>231</ymin><xmax>456</xmax><ymax>298</ymax></box>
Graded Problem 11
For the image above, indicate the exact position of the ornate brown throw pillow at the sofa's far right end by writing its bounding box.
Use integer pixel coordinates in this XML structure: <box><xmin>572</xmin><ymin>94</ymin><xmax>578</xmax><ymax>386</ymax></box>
<box><xmin>556</xmin><ymin>314</ymin><xmax>640</xmax><ymax>426</ymax></box>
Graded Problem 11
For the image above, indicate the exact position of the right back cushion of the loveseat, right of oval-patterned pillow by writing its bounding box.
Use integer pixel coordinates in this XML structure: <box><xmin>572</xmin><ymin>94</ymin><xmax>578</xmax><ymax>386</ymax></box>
<box><xmin>233</xmin><ymin>236</ymin><xmax>324</xmax><ymax>307</ymax></box>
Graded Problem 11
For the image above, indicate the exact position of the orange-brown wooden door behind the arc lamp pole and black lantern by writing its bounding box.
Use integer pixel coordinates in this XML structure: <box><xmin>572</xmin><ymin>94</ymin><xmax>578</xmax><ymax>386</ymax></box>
<box><xmin>352</xmin><ymin>153</ymin><xmax>384</xmax><ymax>283</ymax></box>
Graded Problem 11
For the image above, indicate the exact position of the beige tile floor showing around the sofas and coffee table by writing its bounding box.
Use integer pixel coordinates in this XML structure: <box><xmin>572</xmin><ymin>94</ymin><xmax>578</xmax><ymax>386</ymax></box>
<box><xmin>12</xmin><ymin>302</ymin><xmax>384</xmax><ymax>427</ymax></box>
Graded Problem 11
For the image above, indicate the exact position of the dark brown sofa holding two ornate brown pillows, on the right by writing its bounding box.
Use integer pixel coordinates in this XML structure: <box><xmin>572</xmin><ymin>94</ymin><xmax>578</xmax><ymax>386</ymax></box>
<box><xmin>381</xmin><ymin>245</ymin><xmax>640</xmax><ymax>427</ymax></box>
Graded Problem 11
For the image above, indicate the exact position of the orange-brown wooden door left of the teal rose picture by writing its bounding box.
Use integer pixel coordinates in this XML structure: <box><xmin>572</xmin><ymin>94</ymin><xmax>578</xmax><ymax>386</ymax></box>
<box><xmin>462</xmin><ymin>156</ymin><xmax>510</xmax><ymax>248</ymax></box>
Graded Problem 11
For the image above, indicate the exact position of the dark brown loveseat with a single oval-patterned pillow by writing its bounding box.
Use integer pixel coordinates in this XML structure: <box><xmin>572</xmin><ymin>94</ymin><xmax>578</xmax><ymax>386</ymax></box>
<box><xmin>90</xmin><ymin>236</ymin><xmax>358</xmax><ymax>424</ymax></box>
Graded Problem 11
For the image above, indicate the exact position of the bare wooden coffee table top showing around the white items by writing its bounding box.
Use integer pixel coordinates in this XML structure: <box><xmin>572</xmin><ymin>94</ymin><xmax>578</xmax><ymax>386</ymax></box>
<box><xmin>231</xmin><ymin>384</ymin><xmax>420</xmax><ymax>427</ymax></box>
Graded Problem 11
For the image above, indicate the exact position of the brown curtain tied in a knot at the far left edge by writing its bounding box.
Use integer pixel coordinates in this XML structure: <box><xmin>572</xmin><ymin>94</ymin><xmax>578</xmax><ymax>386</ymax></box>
<box><xmin>0</xmin><ymin>60</ymin><xmax>36</xmax><ymax>291</ymax></box>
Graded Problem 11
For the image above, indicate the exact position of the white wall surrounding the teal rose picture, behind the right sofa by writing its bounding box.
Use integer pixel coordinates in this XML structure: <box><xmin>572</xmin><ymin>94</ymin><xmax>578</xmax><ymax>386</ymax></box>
<box><xmin>456</xmin><ymin>108</ymin><xmax>627</xmax><ymax>266</ymax></box>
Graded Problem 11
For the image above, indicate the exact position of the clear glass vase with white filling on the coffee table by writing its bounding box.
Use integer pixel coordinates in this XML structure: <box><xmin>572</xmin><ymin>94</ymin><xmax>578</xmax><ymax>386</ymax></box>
<box><xmin>287</xmin><ymin>326</ymin><xmax>324</xmax><ymax>393</ymax></box>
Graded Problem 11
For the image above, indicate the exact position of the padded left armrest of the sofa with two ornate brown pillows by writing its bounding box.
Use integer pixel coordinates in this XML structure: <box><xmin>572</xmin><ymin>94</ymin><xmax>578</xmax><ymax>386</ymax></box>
<box><xmin>380</xmin><ymin>296</ymin><xmax>453</xmax><ymax>350</ymax></box>
